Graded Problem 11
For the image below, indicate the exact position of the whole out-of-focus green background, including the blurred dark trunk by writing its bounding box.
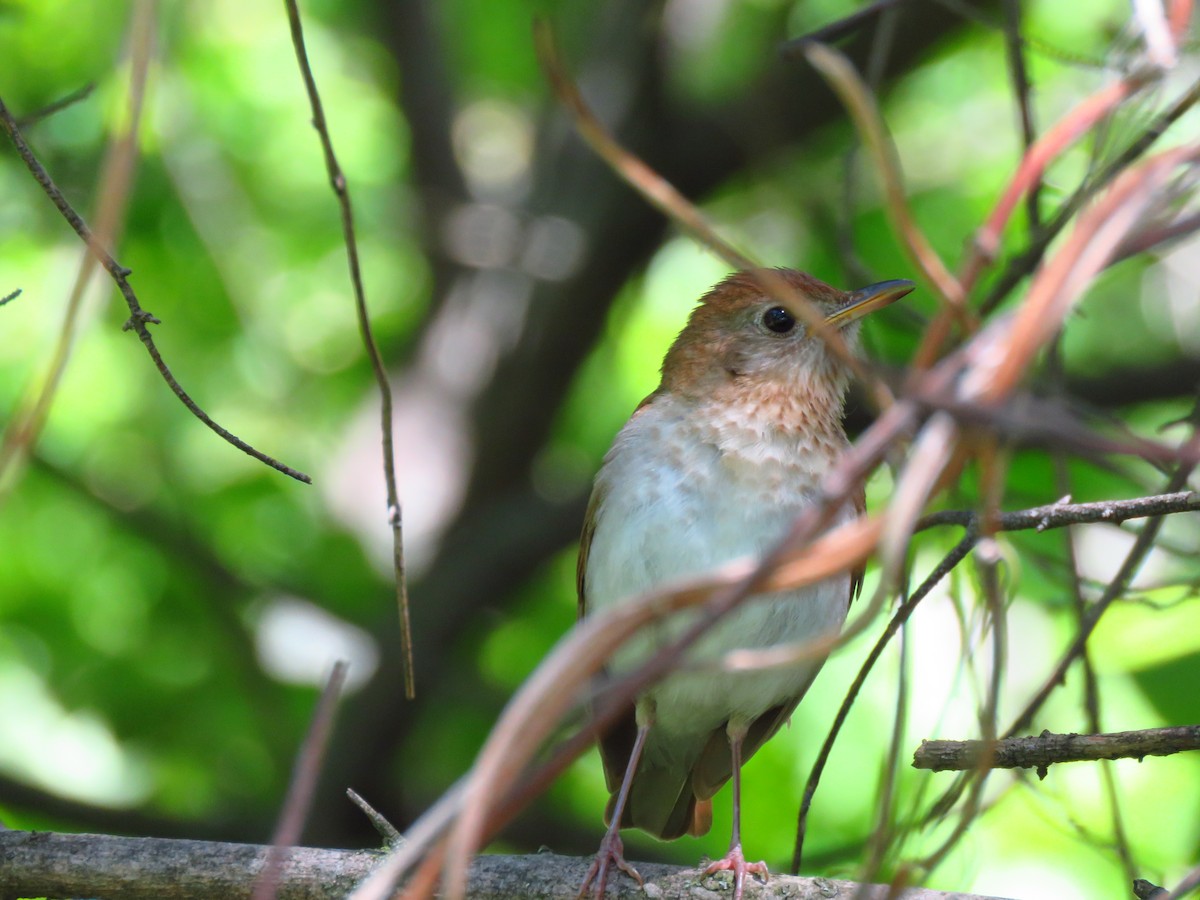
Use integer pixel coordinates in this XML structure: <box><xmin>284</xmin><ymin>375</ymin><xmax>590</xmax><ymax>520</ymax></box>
<box><xmin>0</xmin><ymin>0</ymin><xmax>1200</xmax><ymax>898</ymax></box>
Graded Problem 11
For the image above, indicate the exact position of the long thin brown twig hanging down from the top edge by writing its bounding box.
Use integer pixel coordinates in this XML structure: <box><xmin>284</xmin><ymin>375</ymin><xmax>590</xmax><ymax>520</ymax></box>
<box><xmin>283</xmin><ymin>0</ymin><xmax>416</xmax><ymax>700</ymax></box>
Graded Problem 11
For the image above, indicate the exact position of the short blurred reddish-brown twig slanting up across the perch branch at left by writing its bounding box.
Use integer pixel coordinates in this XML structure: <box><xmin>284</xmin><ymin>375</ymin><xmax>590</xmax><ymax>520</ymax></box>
<box><xmin>253</xmin><ymin>660</ymin><xmax>347</xmax><ymax>900</ymax></box>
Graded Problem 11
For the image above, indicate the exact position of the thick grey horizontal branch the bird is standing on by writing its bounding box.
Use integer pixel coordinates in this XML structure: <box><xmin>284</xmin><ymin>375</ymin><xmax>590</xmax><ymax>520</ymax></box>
<box><xmin>0</xmin><ymin>830</ymin><xmax>1017</xmax><ymax>900</ymax></box>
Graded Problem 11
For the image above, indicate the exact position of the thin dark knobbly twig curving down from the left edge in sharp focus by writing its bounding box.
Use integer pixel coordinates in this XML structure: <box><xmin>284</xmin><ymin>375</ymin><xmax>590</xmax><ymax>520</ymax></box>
<box><xmin>0</xmin><ymin>97</ymin><xmax>312</xmax><ymax>485</ymax></box>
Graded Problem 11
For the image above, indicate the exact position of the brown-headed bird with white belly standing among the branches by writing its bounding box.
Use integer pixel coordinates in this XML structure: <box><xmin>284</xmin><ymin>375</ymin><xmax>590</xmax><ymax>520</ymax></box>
<box><xmin>576</xmin><ymin>269</ymin><xmax>914</xmax><ymax>900</ymax></box>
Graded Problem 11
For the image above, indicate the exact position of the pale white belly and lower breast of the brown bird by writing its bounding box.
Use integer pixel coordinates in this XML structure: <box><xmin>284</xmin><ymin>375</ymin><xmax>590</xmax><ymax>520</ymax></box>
<box><xmin>584</xmin><ymin>400</ymin><xmax>850</xmax><ymax>733</ymax></box>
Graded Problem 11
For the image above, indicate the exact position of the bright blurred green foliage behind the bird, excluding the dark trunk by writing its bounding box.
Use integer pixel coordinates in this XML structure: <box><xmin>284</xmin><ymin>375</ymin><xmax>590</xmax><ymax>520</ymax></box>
<box><xmin>0</xmin><ymin>0</ymin><xmax>1200</xmax><ymax>898</ymax></box>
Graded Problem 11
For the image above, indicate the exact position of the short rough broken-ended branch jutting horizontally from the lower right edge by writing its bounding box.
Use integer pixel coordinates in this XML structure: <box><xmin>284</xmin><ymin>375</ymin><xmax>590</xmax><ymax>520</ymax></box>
<box><xmin>912</xmin><ymin>725</ymin><xmax>1200</xmax><ymax>778</ymax></box>
